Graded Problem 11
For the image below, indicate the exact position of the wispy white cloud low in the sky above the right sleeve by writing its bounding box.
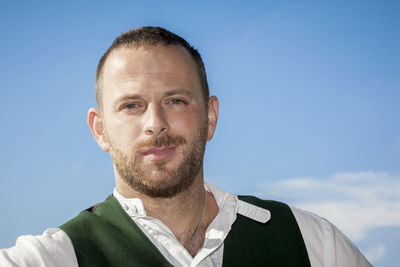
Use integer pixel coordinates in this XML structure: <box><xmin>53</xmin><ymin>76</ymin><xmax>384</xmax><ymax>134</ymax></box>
<box><xmin>258</xmin><ymin>172</ymin><xmax>400</xmax><ymax>243</ymax></box>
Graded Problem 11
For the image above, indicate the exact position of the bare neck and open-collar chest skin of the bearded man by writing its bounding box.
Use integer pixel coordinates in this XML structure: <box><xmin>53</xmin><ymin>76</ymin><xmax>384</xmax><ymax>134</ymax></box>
<box><xmin>116</xmin><ymin>171</ymin><xmax>218</xmax><ymax>256</ymax></box>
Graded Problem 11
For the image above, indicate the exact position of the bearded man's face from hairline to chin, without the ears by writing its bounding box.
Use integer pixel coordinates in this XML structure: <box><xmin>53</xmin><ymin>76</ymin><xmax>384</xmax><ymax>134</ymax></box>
<box><xmin>101</xmin><ymin>46</ymin><xmax>211</xmax><ymax>197</ymax></box>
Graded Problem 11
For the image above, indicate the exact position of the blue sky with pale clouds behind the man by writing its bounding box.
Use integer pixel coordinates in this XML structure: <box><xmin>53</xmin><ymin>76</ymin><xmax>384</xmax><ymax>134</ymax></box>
<box><xmin>0</xmin><ymin>1</ymin><xmax>400</xmax><ymax>266</ymax></box>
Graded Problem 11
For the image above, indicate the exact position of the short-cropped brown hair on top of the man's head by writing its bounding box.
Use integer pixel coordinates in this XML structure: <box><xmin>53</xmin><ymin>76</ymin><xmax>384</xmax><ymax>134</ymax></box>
<box><xmin>96</xmin><ymin>26</ymin><xmax>210</xmax><ymax>109</ymax></box>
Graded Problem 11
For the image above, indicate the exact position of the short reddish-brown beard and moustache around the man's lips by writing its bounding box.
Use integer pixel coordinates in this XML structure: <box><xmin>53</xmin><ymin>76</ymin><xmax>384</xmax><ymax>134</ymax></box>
<box><xmin>110</xmin><ymin>122</ymin><xmax>208</xmax><ymax>198</ymax></box>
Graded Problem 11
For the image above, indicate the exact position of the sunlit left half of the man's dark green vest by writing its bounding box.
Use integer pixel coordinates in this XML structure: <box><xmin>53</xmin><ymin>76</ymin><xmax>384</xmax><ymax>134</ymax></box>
<box><xmin>60</xmin><ymin>196</ymin><xmax>172</xmax><ymax>267</ymax></box>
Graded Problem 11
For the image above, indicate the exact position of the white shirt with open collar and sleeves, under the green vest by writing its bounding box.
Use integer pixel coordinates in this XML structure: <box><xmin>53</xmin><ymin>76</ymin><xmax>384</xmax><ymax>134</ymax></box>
<box><xmin>0</xmin><ymin>182</ymin><xmax>372</xmax><ymax>267</ymax></box>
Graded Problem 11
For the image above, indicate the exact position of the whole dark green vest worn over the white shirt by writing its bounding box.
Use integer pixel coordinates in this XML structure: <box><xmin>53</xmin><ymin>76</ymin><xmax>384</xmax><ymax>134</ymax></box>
<box><xmin>60</xmin><ymin>196</ymin><xmax>311</xmax><ymax>267</ymax></box>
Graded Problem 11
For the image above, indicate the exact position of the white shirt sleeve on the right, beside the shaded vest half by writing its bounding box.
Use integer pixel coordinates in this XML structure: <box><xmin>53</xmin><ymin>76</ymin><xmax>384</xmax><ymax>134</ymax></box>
<box><xmin>291</xmin><ymin>207</ymin><xmax>372</xmax><ymax>267</ymax></box>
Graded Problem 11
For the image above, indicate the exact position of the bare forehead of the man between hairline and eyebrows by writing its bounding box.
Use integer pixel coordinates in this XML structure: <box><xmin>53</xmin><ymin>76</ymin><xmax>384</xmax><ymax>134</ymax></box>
<box><xmin>101</xmin><ymin>45</ymin><xmax>201</xmax><ymax>100</ymax></box>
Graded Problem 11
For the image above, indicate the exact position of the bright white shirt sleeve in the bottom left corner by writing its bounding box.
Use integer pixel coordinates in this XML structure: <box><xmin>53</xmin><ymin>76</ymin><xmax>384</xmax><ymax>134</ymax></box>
<box><xmin>0</xmin><ymin>228</ymin><xmax>78</xmax><ymax>267</ymax></box>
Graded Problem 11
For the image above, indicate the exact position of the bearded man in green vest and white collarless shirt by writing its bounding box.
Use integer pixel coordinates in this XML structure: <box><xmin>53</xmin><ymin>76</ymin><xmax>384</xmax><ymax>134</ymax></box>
<box><xmin>0</xmin><ymin>27</ymin><xmax>370</xmax><ymax>266</ymax></box>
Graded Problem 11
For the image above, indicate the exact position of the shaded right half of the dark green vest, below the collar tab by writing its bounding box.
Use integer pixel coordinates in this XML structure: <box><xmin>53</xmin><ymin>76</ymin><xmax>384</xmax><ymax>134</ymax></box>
<box><xmin>223</xmin><ymin>196</ymin><xmax>310</xmax><ymax>266</ymax></box>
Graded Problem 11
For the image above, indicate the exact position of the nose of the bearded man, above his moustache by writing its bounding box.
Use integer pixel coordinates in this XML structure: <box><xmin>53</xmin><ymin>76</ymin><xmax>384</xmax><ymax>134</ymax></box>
<box><xmin>144</xmin><ymin>105</ymin><xmax>169</xmax><ymax>135</ymax></box>
